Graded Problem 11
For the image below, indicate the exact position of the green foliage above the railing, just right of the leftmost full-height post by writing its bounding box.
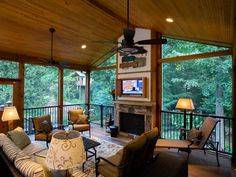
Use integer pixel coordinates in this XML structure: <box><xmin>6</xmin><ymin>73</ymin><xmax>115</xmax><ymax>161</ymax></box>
<box><xmin>24</xmin><ymin>64</ymin><xmax>58</xmax><ymax>108</ymax></box>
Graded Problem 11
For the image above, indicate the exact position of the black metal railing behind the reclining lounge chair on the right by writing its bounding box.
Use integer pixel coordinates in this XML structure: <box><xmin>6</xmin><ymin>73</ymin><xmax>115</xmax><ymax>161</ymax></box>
<box><xmin>161</xmin><ymin>111</ymin><xmax>232</xmax><ymax>154</ymax></box>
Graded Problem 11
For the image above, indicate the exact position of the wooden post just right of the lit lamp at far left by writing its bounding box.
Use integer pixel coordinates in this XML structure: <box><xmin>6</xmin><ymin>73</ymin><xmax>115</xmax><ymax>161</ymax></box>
<box><xmin>17</xmin><ymin>62</ymin><xmax>25</xmax><ymax>128</ymax></box>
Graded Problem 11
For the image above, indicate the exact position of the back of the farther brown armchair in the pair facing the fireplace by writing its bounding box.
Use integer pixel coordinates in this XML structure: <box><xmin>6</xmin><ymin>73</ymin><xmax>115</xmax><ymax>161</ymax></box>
<box><xmin>144</xmin><ymin>127</ymin><xmax>159</xmax><ymax>162</ymax></box>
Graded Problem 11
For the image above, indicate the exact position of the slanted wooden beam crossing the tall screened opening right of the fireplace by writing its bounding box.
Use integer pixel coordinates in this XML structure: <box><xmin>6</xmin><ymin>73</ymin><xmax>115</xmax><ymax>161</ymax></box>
<box><xmin>158</xmin><ymin>50</ymin><xmax>232</xmax><ymax>63</ymax></box>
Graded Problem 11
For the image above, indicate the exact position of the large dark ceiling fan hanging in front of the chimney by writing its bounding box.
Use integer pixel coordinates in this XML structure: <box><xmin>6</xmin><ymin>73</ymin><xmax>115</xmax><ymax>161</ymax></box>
<box><xmin>93</xmin><ymin>0</ymin><xmax>167</xmax><ymax>56</ymax></box>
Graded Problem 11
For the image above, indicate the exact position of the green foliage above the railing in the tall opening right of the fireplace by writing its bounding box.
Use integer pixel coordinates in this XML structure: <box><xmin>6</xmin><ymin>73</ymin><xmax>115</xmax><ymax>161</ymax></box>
<box><xmin>163</xmin><ymin>39</ymin><xmax>232</xmax><ymax>116</ymax></box>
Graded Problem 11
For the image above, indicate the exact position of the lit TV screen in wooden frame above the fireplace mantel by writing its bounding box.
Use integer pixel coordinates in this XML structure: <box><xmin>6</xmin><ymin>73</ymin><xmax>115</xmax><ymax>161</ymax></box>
<box><xmin>121</xmin><ymin>79</ymin><xmax>143</xmax><ymax>95</ymax></box>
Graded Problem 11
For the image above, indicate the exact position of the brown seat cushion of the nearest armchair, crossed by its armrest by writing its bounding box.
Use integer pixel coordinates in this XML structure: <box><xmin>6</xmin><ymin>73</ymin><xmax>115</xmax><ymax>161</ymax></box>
<box><xmin>98</xmin><ymin>149</ymin><xmax>123</xmax><ymax>177</ymax></box>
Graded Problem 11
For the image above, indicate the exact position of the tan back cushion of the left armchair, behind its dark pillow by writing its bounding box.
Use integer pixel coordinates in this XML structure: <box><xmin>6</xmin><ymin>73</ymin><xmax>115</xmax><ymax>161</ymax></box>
<box><xmin>32</xmin><ymin>115</ymin><xmax>53</xmax><ymax>133</ymax></box>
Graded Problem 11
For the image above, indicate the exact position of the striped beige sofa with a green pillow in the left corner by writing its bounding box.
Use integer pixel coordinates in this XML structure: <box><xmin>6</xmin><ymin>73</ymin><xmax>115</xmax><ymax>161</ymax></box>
<box><xmin>0</xmin><ymin>127</ymin><xmax>87</xmax><ymax>177</ymax></box>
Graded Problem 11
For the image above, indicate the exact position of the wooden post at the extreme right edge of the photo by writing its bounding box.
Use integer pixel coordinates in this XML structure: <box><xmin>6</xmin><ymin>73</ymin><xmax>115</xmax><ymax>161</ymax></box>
<box><xmin>232</xmin><ymin>20</ymin><xmax>236</xmax><ymax>162</ymax></box>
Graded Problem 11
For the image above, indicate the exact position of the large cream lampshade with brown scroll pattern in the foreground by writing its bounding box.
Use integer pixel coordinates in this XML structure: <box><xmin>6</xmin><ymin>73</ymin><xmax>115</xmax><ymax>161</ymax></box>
<box><xmin>46</xmin><ymin>130</ymin><xmax>86</xmax><ymax>170</ymax></box>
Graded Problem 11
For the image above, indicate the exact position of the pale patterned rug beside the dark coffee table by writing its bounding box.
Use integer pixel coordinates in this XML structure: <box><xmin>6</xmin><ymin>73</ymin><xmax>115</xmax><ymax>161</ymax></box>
<box><xmin>74</xmin><ymin>137</ymin><xmax>122</xmax><ymax>177</ymax></box>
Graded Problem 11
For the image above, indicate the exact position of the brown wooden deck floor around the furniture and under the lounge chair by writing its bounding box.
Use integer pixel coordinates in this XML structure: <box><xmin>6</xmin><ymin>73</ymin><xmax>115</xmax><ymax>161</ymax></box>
<box><xmin>31</xmin><ymin>124</ymin><xmax>236</xmax><ymax>177</ymax></box>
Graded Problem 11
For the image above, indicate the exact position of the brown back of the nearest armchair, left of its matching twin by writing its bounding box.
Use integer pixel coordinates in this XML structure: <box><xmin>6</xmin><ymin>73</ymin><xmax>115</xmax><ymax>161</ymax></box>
<box><xmin>120</xmin><ymin>136</ymin><xmax>147</xmax><ymax>177</ymax></box>
